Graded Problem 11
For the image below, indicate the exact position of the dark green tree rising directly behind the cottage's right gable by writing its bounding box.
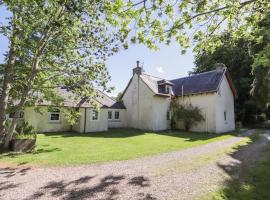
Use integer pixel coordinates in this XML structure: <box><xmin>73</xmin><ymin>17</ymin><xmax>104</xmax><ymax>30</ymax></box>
<box><xmin>192</xmin><ymin>33</ymin><xmax>255</xmax><ymax>122</ymax></box>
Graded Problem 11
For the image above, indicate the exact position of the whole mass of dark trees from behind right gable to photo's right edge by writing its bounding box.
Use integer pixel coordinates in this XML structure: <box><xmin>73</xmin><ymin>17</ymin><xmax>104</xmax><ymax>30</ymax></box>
<box><xmin>192</xmin><ymin>12</ymin><xmax>270</xmax><ymax>123</ymax></box>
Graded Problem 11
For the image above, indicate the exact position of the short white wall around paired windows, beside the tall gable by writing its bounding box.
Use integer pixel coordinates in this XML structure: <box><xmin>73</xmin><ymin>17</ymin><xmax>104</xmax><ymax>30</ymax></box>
<box><xmin>107</xmin><ymin>109</ymin><xmax>127</xmax><ymax>128</ymax></box>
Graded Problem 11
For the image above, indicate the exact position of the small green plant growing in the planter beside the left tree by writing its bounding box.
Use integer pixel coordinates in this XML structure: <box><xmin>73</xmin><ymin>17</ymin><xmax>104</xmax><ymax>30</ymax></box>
<box><xmin>13</xmin><ymin>122</ymin><xmax>37</xmax><ymax>139</ymax></box>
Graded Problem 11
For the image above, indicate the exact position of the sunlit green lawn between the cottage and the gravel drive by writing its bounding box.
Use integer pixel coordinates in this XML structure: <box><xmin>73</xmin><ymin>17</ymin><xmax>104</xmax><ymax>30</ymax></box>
<box><xmin>0</xmin><ymin>129</ymin><xmax>234</xmax><ymax>166</ymax></box>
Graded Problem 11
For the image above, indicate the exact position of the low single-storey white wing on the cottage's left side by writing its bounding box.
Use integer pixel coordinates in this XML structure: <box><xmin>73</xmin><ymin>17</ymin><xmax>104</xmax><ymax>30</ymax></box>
<box><xmin>10</xmin><ymin>88</ymin><xmax>126</xmax><ymax>133</ymax></box>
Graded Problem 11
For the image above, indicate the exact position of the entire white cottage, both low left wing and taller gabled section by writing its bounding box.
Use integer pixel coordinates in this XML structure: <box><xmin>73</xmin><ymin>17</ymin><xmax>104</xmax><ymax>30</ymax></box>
<box><xmin>9</xmin><ymin>62</ymin><xmax>236</xmax><ymax>133</ymax></box>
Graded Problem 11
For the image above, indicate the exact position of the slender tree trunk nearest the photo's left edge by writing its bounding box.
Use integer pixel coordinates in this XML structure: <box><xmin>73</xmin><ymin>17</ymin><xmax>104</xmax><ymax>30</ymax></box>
<box><xmin>0</xmin><ymin>43</ymin><xmax>16</xmax><ymax>141</ymax></box>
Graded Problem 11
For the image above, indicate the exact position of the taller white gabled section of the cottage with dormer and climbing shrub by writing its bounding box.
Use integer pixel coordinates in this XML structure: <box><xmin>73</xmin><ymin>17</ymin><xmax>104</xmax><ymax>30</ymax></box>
<box><xmin>122</xmin><ymin>62</ymin><xmax>237</xmax><ymax>133</ymax></box>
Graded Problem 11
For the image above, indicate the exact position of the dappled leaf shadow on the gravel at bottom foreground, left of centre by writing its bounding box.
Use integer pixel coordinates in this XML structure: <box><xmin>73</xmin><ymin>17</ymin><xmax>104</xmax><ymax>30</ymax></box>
<box><xmin>23</xmin><ymin>175</ymin><xmax>156</xmax><ymax>200</ymax></box>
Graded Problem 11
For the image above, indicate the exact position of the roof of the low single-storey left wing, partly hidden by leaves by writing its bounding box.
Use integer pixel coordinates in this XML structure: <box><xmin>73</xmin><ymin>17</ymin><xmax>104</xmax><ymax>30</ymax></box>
<box><xmin>38</xmin><ymin>88</ymin><xmax>125</xmax><ymax>109</ymax></box>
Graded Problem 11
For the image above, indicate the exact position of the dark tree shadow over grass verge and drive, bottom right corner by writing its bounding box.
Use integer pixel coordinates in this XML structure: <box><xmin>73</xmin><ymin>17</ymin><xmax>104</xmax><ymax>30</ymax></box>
<box><xmin>212</xmin><ymin>130</ymin><xmax>270</xmax><ymax>200</ymax></box>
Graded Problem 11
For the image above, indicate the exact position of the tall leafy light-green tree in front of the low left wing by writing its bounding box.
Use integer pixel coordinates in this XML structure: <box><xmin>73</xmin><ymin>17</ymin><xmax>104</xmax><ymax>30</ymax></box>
<box><xmin>0</xmin><ymin>1</ymin><xmax>125</xmax><ymax>145</ymax></box>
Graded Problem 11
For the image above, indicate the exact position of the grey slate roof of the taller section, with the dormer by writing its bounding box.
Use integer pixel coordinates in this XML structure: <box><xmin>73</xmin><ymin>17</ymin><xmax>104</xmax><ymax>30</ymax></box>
<box><xmin>140</xmin><ymin>67</ymin><xmax>236</xmax><ymax>96</ymax></box>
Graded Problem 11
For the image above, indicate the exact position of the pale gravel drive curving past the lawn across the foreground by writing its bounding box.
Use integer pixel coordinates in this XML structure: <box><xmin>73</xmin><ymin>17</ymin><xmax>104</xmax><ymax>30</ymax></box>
<box><xmin>0</xmin><ymin>130</ymin><xmax>270</xmax><ymax>200</ymax></box>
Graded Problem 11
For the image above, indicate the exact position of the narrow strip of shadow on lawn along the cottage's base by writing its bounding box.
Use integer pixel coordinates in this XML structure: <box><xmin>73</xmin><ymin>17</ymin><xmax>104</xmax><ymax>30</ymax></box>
<box><xmin>40</xmin><ymin>128</ymin><xmax>238</xmax><ymax>141</ymax></box>
